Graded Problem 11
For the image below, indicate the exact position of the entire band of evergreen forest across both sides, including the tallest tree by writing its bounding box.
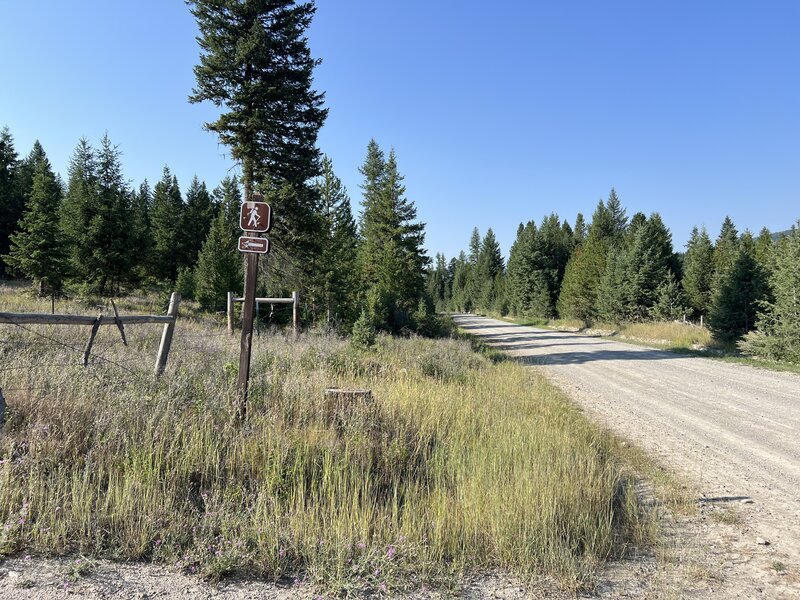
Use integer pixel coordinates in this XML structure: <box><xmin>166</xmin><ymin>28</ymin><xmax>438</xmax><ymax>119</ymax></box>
<box><xmin>0</xmin><ymin>0</ymin><xmax>800</xmax><ymax>360</ymax></box>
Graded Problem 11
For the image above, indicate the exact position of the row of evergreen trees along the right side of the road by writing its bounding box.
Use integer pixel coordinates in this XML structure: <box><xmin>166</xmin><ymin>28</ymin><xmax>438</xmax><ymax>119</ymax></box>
<box><xmin>427</xmin><ymin>189</ymin><xmax>800</xmax><ymax>360</ymax></box>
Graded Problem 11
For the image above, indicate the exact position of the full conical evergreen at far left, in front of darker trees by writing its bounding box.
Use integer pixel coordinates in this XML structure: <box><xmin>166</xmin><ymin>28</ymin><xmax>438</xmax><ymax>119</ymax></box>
<box><xmin>5</xmin><ymin>142</ymin><xmax>67</xmax><ymax>296</ymax></box>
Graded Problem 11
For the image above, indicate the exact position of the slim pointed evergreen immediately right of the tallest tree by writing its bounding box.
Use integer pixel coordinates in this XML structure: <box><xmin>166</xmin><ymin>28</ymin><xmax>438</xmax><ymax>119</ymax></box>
<box><xmin>316</xmin><ymin>156</ymin><xmax>359</xmax><ymax>329</ymax></box>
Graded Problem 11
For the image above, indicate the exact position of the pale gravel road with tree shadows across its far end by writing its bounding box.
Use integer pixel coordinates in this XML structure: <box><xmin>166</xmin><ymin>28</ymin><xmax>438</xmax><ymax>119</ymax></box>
<box><xmin>455</xmin><ymin>315</ymin><xmax>800</xmax><ymax>598</ymax></box>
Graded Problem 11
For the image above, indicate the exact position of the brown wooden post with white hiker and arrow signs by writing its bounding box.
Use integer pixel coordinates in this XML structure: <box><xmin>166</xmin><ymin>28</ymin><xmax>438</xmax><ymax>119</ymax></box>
<box><xmin>237</xmin><ymin>194</ymin><xmax>272</xmax><ymax>419</ymax></box>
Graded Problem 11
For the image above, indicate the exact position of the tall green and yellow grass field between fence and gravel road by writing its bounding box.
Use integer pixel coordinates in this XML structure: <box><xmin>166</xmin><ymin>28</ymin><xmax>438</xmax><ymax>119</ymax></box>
<box><xmin>0</xmin><ymin>292</ymin><xmax>655</xmax><ymax>595</ymax></box>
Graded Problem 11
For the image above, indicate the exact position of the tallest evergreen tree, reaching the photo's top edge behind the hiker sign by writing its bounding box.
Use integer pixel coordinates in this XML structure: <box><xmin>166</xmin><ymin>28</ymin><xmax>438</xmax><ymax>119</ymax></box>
<box><xmin>189</xmin><ymin>0</ymin><xmax>327</xmax><ymax>305</ymax></box>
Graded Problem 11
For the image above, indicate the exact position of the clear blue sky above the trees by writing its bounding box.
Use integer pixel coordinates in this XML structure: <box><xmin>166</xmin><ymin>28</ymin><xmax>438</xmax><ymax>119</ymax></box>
<box><xmin>0</xmin><ymin>0</ymin><xmax>800</xmax><ymax>258</ymax></box>
